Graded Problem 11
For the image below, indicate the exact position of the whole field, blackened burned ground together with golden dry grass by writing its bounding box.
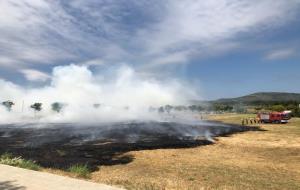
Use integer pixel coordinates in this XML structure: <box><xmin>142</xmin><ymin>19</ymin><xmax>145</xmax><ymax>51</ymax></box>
<box><xmin>0</xmin><ymin>114</ymin><xmax>300</xmax><ymax>190</ymax></box>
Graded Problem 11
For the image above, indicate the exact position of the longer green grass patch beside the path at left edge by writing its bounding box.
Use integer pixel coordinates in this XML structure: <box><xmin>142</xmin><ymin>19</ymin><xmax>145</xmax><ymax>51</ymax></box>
<box><xmin>0</xmin><ymin>153</ymin><xmax>41</xmax><ymax>171</ymax></box>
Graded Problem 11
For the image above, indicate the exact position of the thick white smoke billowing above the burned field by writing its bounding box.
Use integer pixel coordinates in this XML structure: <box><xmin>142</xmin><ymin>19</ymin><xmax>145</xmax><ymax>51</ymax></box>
<box><xmin>0</xmin><ymin>64</ymin><xmax>198</xmax><ymax>123</ymax></box>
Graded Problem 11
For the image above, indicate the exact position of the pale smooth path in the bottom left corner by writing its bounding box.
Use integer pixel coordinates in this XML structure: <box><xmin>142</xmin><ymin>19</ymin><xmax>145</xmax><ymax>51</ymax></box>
<box><xmin>0</xmin><ymin>164</ymin><xmax>120</xmax><ymax>190</ymax></box>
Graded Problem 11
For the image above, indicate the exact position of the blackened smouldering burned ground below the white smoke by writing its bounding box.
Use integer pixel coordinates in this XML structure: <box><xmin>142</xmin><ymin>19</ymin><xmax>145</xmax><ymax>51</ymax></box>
<box><xmin>0</xmin><ymin>122</ymin><xmax>255</xmax><ymax>170</ymax></box>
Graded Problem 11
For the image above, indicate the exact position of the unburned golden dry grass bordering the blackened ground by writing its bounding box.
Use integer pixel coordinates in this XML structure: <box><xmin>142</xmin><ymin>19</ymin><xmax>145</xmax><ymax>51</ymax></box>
<box><xmin>47</xmin><ymin>114</ymin><xmax>300</xmax><ymax>189</ymax></box>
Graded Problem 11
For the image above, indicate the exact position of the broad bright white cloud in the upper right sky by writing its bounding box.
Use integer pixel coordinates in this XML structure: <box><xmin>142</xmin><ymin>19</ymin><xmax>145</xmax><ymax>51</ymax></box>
<box><xmin>140</xmin><ymin>0</ymin><xmax>299</xmax><ymax>63</ymax></box>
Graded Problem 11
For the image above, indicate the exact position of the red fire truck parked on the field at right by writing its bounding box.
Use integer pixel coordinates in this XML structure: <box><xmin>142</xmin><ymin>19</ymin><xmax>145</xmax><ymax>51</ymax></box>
<box><xmin>257</xmin><ymin>111</ymin><xmax>291</xmax><ymax>123</ymax></box>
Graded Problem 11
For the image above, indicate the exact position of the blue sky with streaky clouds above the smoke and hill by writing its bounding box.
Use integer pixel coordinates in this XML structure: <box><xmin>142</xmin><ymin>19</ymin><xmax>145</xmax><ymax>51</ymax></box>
<box><xmin>0</xmin><ymin>0</ymin><xmax>300</xmax><ymax>100</ymax></box>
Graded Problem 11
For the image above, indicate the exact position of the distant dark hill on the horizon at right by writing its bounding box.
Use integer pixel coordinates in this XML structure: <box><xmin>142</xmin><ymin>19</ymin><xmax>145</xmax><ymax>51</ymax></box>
<box><xmin>212</xmin><ymin>92</ymin><xmax>300</xmax><ymax>104</ymax></box>
